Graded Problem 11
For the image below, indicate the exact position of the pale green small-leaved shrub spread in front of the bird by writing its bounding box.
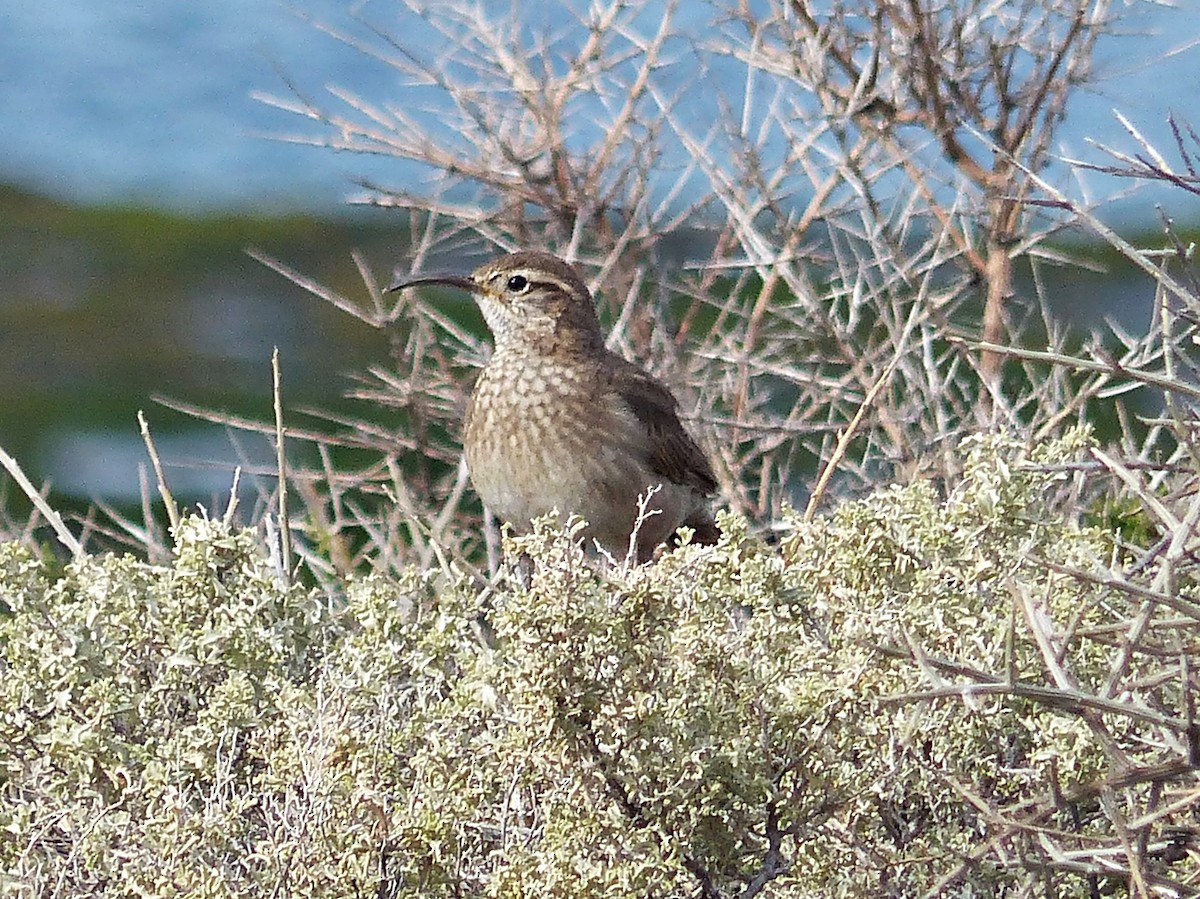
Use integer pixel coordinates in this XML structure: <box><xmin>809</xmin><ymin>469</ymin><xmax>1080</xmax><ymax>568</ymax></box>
<box><xmin>0</xmin><ymin>432</ymin><xmax>1196</xmax><ymax>899</ymax></box>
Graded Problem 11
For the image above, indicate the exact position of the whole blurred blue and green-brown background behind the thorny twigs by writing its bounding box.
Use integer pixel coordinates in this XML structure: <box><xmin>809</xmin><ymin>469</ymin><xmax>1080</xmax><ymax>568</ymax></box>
<box><xmin>0</xmin><ymin>0</ymin><xmax>1200</xmax><ymax>502</ymax></box>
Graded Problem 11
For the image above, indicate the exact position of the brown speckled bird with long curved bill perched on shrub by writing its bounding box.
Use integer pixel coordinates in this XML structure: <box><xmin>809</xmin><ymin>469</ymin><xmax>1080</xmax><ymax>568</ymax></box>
<box><xmin>390</xmin><ymin>252</ymin><xmax>720</xmax><ymax>562</ymax></box>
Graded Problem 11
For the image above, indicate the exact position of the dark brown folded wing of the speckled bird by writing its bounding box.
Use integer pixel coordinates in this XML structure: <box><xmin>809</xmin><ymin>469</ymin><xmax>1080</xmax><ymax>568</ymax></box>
<box><xmin>612</xmin><ymin>355</ymin><xmax>716</xmax><ymax>496</ymax></box>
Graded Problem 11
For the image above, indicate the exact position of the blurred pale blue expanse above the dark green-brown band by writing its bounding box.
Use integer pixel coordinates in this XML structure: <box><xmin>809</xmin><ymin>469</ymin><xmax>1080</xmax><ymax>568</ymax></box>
<box><xmin>0</xmin><ymin>0</ymin><xmax>1200</xmax><ymax>224</ymax></box>
